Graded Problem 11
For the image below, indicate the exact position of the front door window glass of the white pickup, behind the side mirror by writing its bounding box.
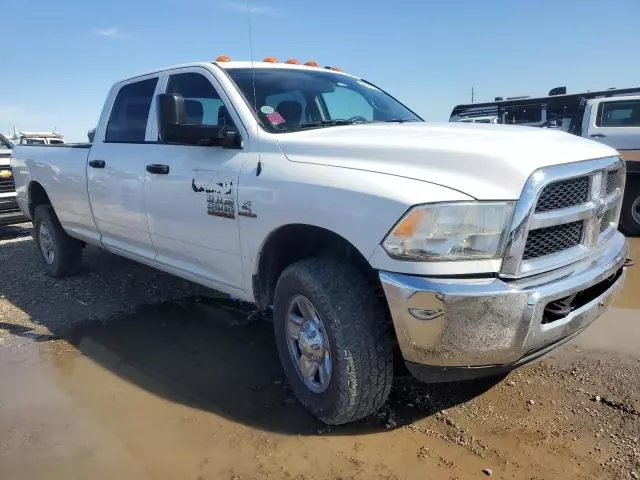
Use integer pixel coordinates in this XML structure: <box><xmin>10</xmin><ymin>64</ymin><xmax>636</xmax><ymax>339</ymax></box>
<box><xmin>167</xmin><ymin>72</ymin><xmax>233</xmax><ymax>127</ymax></box>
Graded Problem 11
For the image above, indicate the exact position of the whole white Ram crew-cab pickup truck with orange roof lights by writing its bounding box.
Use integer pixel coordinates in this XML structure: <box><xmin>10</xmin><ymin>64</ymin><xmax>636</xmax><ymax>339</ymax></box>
<box><xmin>11</xmin><ymin>59</ymin><xmax>627</xmax><ymax>424</ymax></box>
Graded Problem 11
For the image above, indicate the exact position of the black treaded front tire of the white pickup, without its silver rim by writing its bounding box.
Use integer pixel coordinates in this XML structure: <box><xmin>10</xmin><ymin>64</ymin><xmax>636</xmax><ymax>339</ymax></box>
<box><xmin>273</xmin><ymin>257</ymin><xmax>393</xmax><ymax>425</ymax></box>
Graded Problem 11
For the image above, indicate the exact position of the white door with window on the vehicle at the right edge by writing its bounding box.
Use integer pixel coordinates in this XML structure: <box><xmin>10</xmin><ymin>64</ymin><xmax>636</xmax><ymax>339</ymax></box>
<box><xmin>583</xmin><ymin>97</ymin><xmax>640</xmax><ymax>159</ymax></box>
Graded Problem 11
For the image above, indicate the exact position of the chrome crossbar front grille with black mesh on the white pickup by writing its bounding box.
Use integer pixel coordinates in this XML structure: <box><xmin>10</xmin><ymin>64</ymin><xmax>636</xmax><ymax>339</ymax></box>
<box><xmin>501</xmin><ymin>157</ymin><xmax>626</xmax><ymax>278</ymax></box>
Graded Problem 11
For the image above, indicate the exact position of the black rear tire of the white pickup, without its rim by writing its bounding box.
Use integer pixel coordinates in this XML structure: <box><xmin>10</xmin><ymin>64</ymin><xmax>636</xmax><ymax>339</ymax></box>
<box><xmin>33</xmin><ymin>205</ymin><xmax>83</xmax><ymax>278</ymax></box>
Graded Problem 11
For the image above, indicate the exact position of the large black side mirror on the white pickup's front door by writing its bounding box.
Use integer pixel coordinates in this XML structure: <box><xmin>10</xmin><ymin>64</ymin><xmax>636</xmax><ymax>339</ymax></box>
<box><xmin>157</xmin><ymin>93</ymin><xmax>220</xmax><ymax>146</ymax></box>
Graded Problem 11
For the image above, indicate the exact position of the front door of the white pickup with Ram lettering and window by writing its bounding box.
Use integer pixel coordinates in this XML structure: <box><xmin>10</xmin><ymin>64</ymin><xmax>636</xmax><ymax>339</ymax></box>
<box><xmin>145</xmin><ymin>67</ymin><xmax>246</xmax><ymax>290</ymax></box>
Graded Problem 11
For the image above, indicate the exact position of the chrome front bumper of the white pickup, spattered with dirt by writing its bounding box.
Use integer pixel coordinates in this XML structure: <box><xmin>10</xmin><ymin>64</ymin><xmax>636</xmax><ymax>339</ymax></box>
<box><xmin>380</xmin><ymin>232</ymin><xmax>627</xmax><ymax>378</ymax></box>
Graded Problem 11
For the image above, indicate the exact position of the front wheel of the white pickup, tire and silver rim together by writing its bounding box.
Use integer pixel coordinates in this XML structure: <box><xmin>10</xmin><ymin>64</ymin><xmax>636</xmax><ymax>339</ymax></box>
<box><xmin>274</xmin><ymin>257</ymin><xmax>393</xmax><ymax>425</ymax></box>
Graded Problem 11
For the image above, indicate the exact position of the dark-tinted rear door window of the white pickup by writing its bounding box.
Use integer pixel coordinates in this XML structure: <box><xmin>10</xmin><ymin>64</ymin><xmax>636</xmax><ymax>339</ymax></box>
<box><xmin>105</xmin><ymin>78</ymin><xmax>158</xmax><ymax>143</ymax></box>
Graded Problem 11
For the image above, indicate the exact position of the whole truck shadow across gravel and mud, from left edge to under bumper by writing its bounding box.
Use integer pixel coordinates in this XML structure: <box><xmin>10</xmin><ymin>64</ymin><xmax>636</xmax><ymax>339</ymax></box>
<box><xmin>0</xmin><ymin>235</ymin><xmax>498</xmax><ymax>435</ymax></box>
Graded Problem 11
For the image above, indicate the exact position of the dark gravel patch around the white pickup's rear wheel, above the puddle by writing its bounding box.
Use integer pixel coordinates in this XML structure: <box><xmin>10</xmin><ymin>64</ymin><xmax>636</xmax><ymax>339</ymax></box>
<box><xmin>0</xmin><ymin>224</ymin><xmax>216</xmax><ymax>342</ymax></box>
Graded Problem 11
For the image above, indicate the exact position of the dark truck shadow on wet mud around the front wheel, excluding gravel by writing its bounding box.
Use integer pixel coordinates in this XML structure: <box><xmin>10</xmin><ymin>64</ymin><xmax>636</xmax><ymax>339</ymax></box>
<box><xmin>62</xmin><ymin>297</ymin><xmax>499</xmax><ymax>435</ymax></box>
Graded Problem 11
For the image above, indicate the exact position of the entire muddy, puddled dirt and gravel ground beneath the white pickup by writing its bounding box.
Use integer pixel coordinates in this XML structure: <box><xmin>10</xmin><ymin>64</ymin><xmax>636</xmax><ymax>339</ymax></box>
<box><xmin>0</xmin><ymin>225</ymin><xmax>640</xmax><ymax>480</ymax></box>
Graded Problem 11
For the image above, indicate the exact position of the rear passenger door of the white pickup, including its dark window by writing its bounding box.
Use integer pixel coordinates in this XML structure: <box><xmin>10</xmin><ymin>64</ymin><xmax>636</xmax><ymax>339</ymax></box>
<box><xmin>87</xmin><ymin>75</ymin><xmax>159</xmax><ymax>259</ymax></box>
